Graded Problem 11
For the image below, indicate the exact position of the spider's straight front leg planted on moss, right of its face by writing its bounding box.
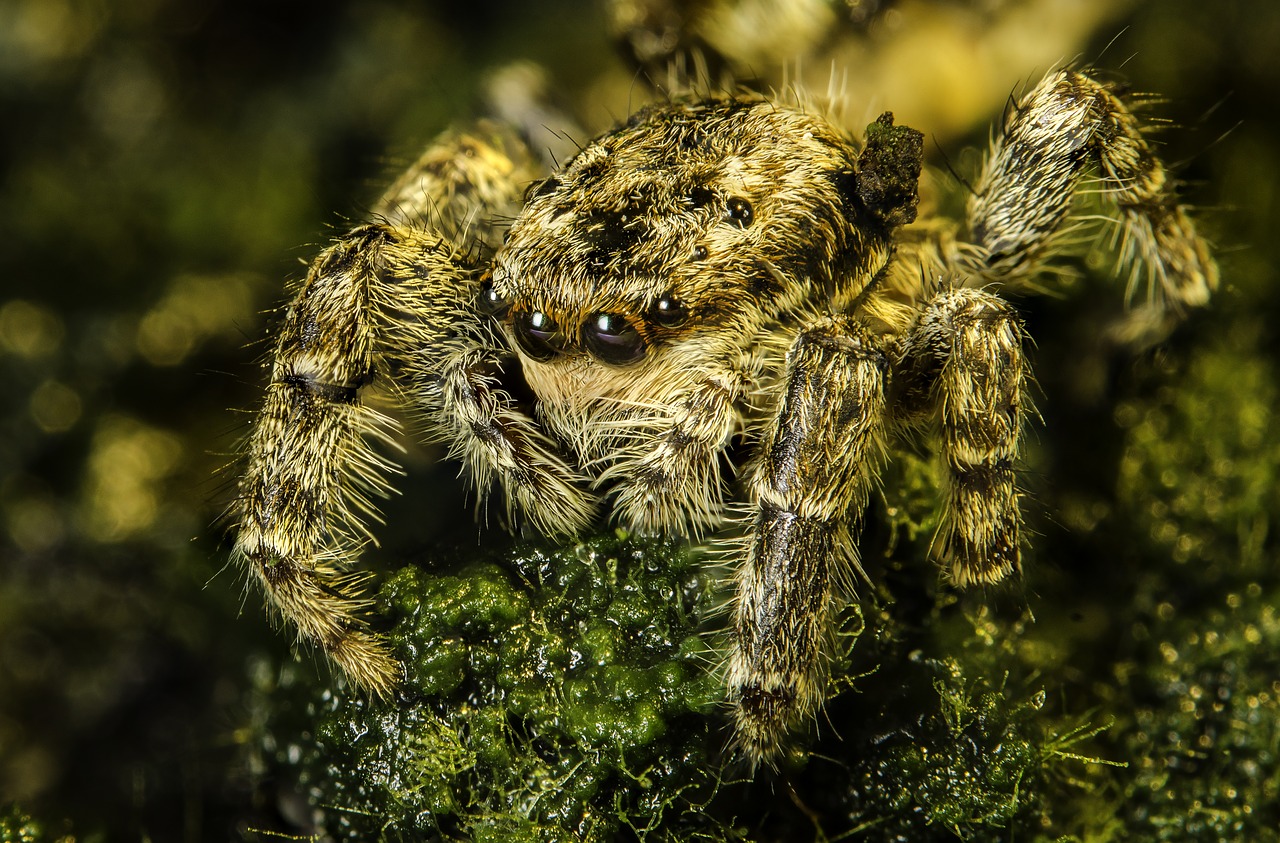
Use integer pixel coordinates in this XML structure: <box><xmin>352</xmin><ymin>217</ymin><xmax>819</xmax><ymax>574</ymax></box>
<box><xmin>727</xmin><ymin>319</ymin><xmax>888</xmax><ymax>766</ymax></box>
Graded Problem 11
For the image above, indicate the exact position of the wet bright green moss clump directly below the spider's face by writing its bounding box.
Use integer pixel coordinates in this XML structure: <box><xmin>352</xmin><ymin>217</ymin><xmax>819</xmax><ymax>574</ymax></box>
<box><xmin>280</xmin><ymin>535</ymin><xmax>724</xmax><ymax>840</ymax></box>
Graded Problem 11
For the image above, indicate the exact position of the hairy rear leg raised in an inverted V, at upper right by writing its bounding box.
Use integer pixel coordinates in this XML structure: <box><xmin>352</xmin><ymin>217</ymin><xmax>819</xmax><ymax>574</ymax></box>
<box><xmin>966</xmin><ymin>70</ymin><xmax>1219</xmax><ymax>315</ymax></box>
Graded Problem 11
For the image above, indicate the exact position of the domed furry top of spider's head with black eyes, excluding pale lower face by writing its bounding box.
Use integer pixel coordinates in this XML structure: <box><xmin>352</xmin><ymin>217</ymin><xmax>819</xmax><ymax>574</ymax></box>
<box><xmin>480</xmin><ymin>100</ymin><xmax>919</xmax><ymax>381</ymax></box>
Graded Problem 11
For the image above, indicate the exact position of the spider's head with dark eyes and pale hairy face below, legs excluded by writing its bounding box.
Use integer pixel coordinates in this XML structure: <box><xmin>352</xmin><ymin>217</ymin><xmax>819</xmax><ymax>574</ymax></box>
<box><xmin>483</xmin><ymin>100</ymin><xmax>920</xmax><ymax>532</ymax></box>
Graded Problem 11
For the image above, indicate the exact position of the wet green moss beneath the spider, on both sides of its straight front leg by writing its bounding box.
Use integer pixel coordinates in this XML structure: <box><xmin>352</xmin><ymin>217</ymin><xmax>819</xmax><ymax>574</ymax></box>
<box><xmin>265</xmin><ymin>483</ymin><xmax>1121</xmax><ymax>840</ymax></box>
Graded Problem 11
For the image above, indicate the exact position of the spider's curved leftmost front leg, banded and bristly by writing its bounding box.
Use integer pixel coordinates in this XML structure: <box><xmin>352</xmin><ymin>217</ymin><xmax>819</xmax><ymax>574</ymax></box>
<box><xmin>234</xmin><ymin>225</ymin><xmax>462</xmax><ymax>693</ymax></box>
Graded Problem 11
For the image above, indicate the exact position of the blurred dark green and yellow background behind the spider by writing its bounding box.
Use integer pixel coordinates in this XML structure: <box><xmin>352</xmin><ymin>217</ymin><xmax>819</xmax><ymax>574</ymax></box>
<box><xmin>0</xmin><ymin>0</ymin><xmax>1280</xmax><ymax>840</ymax></box>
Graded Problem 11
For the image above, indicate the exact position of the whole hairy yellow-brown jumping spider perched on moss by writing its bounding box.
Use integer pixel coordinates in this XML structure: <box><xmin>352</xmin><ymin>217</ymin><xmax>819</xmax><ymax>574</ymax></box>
<box><xmin>236</xmin><ymin>70</ymin><xmax>1217</xmax><ymax>764</ymax></box>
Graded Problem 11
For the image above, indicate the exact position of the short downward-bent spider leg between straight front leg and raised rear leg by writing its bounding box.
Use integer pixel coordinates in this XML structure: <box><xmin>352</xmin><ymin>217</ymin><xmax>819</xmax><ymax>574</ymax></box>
<box><xmin>891</xmin><ymin>289</ymin><xmax>1027</xmax><ymax>586</ymax></box>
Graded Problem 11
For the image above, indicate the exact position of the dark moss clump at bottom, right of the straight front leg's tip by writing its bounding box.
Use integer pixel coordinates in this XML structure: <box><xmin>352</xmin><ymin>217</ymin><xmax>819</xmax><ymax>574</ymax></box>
<box><xmin>764</xmin><ymin>618</ymin><xmax>1112</xmax><ymax>840</ymax></box>
